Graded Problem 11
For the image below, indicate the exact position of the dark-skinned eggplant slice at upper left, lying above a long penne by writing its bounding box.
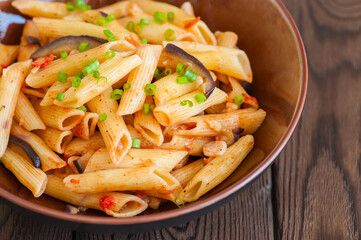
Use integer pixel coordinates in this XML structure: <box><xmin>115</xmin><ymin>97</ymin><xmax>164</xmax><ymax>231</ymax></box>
<box><xmin>30</xmin><ymin>35</ymin><xmax>106</xmax><ymax>59</ymax></box>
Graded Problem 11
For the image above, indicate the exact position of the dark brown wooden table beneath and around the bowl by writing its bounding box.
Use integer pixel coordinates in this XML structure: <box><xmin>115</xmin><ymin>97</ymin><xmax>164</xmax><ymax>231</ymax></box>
<box><xmin>0</xmin><ymin>0</ymin><xmax>361</xmax><ymax>240</ymax></box>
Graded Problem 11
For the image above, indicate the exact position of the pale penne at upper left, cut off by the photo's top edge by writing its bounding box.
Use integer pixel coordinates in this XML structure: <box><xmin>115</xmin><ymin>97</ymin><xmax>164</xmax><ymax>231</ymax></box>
<box><xmin>11</xmin><ymin>0</ymin><xmax>70</xmax><ymax>18</ymax></box>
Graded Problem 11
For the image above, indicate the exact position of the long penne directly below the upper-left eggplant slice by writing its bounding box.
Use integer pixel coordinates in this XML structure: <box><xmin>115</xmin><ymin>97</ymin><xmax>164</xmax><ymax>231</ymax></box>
<box><xmin>25</xmin><ymin>40</ymin><xmax>134</xmax><ymax>88</ymax></box>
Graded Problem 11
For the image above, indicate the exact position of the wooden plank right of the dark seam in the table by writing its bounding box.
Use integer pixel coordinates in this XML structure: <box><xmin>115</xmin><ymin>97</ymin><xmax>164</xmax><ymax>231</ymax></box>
<box><xmin>273</xmin><ymin>0</ymin><xmax>361</xmax><ymax>239</ymax></box>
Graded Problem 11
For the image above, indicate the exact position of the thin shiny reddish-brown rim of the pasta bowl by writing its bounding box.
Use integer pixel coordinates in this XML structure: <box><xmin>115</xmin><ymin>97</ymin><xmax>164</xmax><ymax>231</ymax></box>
<box><xmin>0</xmin><ymin>0</ymin><xmax>308</xmax><ymax>226</ymax></box>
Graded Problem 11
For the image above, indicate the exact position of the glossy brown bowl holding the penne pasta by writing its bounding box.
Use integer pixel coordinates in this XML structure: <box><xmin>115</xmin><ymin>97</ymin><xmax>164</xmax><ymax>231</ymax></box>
<box><xmin>0</xmin><ymin>0</ymin><xmax>307</xmax><ymax>231</ymax></box>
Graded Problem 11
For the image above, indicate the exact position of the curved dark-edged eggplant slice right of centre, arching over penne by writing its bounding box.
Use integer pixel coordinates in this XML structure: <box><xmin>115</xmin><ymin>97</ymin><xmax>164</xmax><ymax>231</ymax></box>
<box><xmin>164</xmin><ymin>43</ymin><xmax>216</xmax><ymax>98</ymax></box>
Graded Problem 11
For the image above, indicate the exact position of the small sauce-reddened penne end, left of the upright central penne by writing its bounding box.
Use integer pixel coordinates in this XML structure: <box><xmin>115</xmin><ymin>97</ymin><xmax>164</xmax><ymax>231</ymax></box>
<box><xmin>72</xmin><ymin>112</ymin><xmax>99</xmax><ymax>140</ymax></box>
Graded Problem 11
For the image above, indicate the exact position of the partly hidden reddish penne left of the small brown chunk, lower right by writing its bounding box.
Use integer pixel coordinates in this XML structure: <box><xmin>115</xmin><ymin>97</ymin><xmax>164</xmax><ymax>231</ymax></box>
<box><xmin>159</xmin><ymin>135</ymin><xmax>214</xmax><ymax>156</ymax></box>
